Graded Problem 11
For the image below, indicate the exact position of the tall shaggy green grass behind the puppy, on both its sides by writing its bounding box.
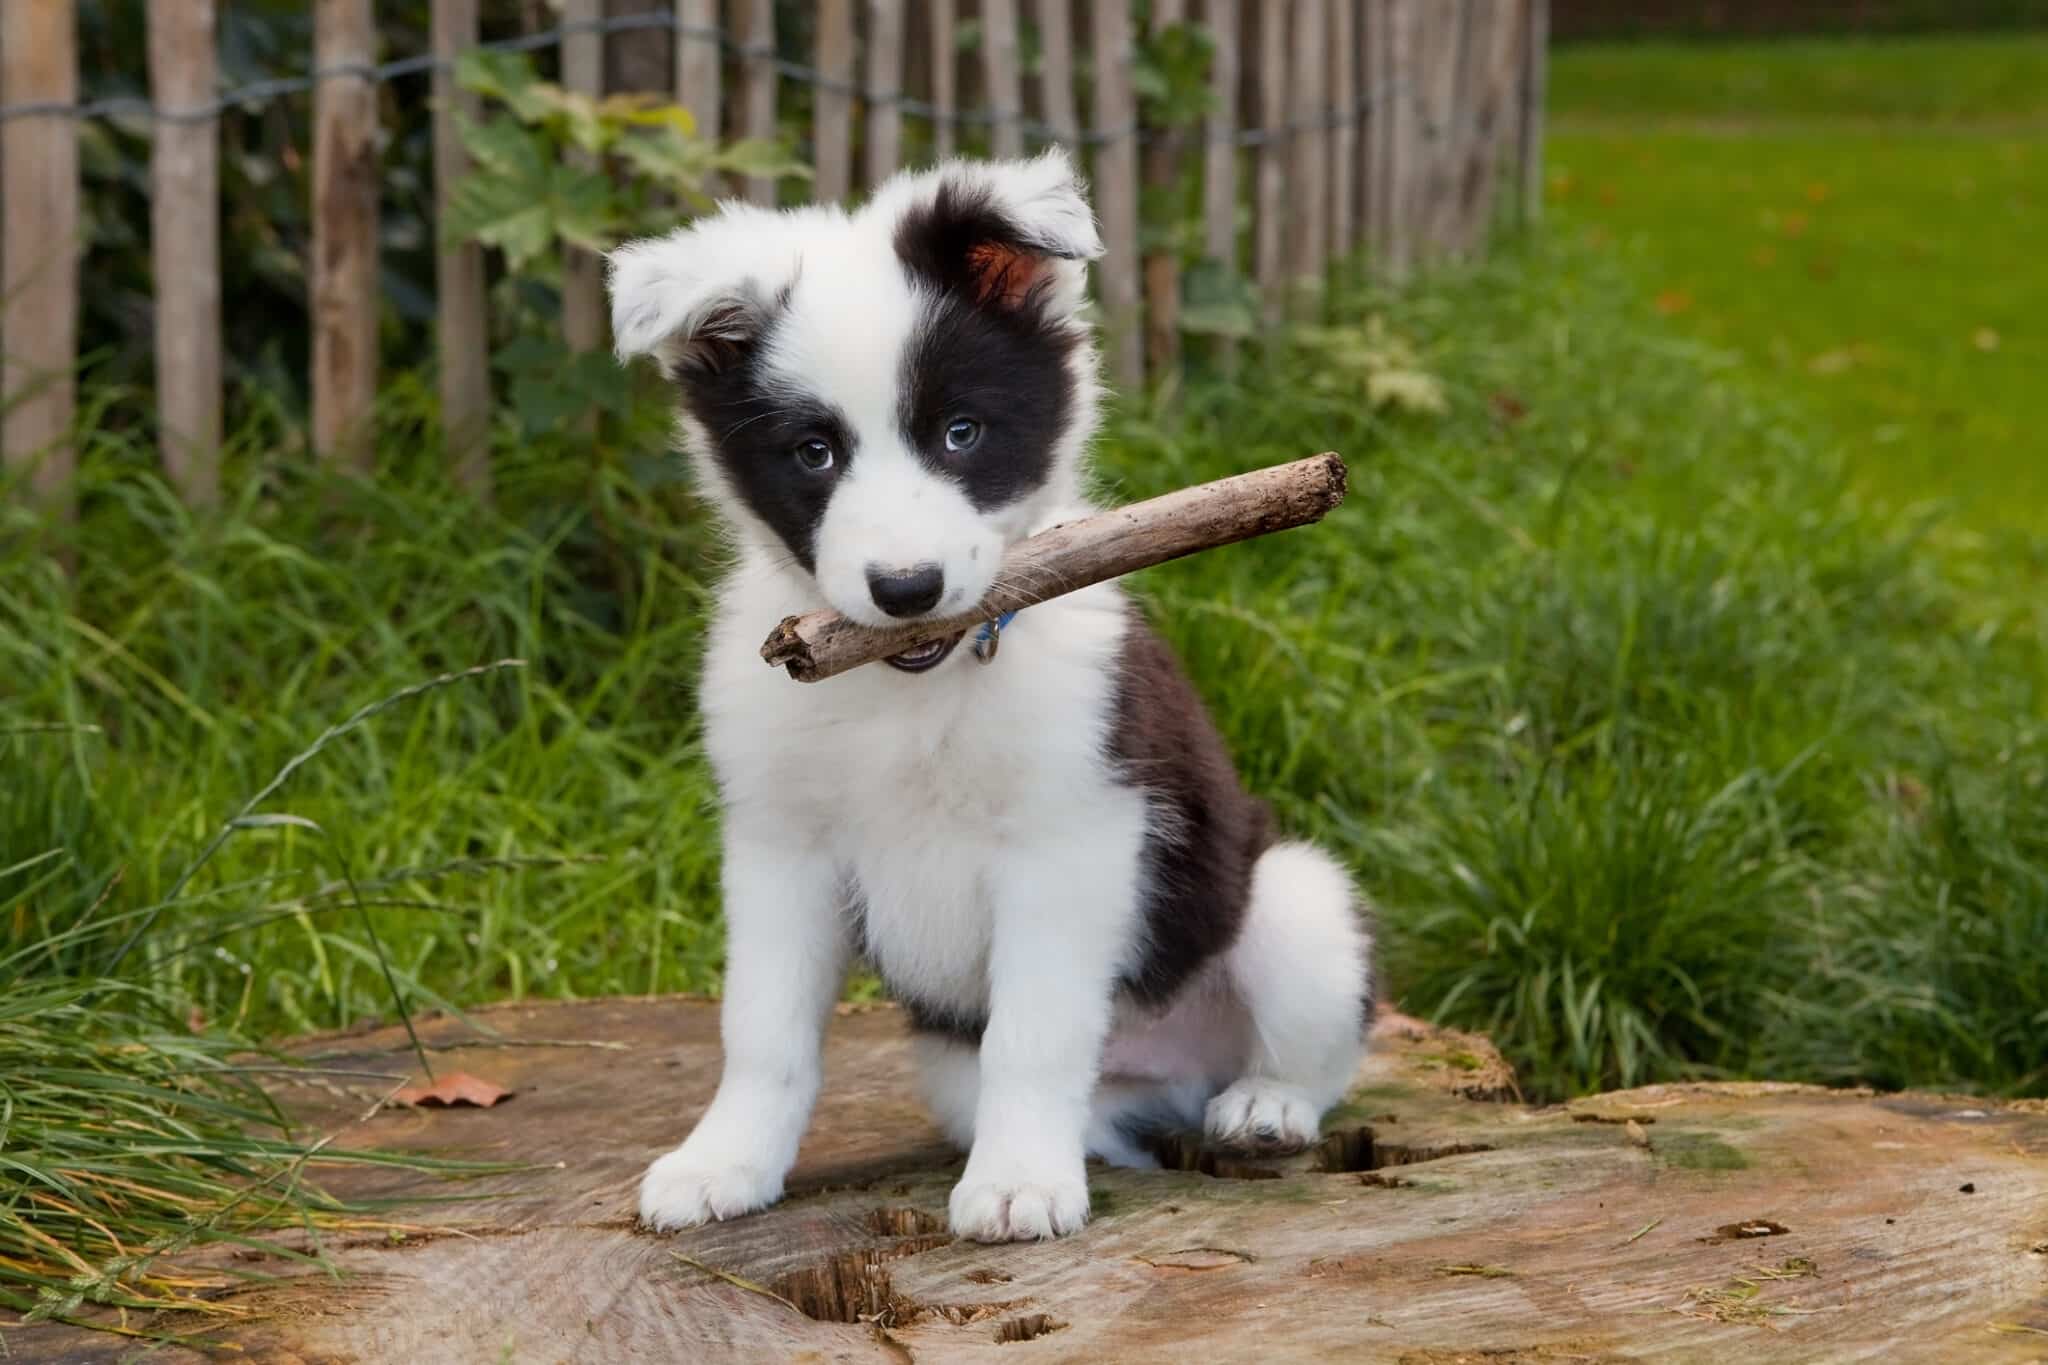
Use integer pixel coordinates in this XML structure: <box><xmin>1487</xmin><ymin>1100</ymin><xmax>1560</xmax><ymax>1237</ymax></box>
<box><xmin>0</xmin><ymin>244</ymin><xmax>2048</xmax><ymax>1095</ymax></box>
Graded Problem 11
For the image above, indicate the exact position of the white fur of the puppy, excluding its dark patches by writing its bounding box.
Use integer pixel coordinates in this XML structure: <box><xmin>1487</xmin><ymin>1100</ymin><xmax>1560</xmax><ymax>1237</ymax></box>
<box><xmin>612</xmin><ymin>153</ymin><xmax>1370</xmax><ymax>1240</ymax></box>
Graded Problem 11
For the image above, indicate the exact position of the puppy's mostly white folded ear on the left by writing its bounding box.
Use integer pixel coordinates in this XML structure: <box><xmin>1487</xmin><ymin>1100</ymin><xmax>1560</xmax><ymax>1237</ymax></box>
<box><xmin>608</xmin><ymin>213</ymin><xmax>774</xmax><ymax>377</ymax></box>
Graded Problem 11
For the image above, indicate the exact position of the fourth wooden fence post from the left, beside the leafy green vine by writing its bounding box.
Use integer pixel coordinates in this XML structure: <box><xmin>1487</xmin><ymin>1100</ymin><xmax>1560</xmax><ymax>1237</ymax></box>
<box><xmin>432</xmin><ymin>0</ymin><xmax>492</xmax><ymax>497</ymax></box>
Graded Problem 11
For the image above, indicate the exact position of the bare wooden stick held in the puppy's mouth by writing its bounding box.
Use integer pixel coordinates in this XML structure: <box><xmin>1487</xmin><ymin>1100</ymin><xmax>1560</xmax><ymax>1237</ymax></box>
<box><xmin>762</xmin><ymin>454</ymin><xmax>1346</xmax><ymax>681</ymax></box>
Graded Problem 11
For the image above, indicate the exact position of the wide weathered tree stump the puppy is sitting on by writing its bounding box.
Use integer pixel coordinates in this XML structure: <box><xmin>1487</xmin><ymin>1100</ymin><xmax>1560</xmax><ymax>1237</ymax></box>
<box><xmin>0</xmin><ymin>999</ymin><xmax>2048</xmax><ymax>1365</ymax></box>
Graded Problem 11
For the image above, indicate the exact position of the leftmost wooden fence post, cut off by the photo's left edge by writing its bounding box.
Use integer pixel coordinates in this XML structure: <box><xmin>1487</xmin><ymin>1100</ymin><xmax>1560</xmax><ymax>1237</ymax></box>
<box><xmin>0</xmin><ymin>0</ymin><xmax>78</xmax><ymax>518</ymax></box>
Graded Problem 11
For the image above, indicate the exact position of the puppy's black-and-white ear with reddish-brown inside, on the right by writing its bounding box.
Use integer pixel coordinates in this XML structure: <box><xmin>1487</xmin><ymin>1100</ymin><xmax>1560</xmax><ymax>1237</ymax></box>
<box><xmin>877</xmin><ymin>147</ymin><xmax>1102</xmax><ymax>317</ymax></box>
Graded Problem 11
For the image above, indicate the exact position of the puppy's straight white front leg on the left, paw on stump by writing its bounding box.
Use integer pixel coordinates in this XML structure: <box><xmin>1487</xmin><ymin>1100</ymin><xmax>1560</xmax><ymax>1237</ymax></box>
<box><xmin>639</xmin><ymin>829</ymin><xmax>850</xmax><ymax>1232</ymax></box>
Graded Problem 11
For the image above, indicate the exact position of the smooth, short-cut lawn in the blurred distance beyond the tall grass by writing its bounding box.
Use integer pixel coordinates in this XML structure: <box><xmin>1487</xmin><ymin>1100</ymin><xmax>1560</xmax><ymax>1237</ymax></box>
<box><xmin>1548</xmin><ymin>35</ymin><xmax>2048</xmax><ymax>536</ymax></box>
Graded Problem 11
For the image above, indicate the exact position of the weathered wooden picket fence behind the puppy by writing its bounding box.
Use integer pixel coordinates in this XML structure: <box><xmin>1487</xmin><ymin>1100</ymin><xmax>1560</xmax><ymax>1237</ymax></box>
<box><xmin>0</xmin><ymin>0</ymin><xmax>1548</xmax><ymax>514</ymax></box>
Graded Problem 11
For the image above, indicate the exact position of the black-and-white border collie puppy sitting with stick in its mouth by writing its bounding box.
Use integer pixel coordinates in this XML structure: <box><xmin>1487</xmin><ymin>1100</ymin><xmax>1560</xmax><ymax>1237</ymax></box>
<box><xmin>610</xmin><ymin>151</ymin><xmax>1372</xmax><ymax>1242</ymax></box>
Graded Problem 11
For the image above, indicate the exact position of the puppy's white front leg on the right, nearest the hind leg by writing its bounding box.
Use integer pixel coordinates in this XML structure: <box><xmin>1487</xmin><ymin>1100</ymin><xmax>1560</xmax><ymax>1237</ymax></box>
<box><xmin>952</xmin><ymin>818</ymin><xmax>1145</xmax><ymax>1242</ymax></box>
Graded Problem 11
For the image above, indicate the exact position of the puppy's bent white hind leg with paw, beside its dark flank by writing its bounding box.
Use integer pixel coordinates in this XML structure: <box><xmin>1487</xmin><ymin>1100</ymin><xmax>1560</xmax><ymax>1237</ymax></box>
<box><xmin>1202</xmin><ymin>843</ymin><xmax>1372</xmax><ymax>1152</ymax></box>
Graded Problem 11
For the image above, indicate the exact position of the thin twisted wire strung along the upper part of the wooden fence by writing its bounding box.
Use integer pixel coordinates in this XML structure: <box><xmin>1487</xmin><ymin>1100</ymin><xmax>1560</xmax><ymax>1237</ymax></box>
<box><xmin>0</xmin><ymin>10</ymin><xmax>1442</xmax><ymax>149</ymax></box>
